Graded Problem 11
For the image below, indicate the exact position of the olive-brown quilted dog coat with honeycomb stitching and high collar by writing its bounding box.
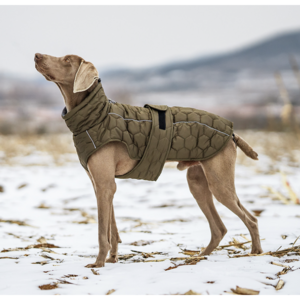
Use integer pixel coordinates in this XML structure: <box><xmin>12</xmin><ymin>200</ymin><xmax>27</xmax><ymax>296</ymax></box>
<box><xmin>62</xmin><ymin>83</ymin><xmax>233</xmax><ymax>181</ymax></box>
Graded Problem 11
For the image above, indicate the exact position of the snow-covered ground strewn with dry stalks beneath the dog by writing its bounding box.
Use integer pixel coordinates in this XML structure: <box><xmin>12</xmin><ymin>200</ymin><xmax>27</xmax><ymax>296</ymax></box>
<box><xmin>0</xmin><ymin>154</ymin><xmax>300</xmax><ymax>295</ymax></box>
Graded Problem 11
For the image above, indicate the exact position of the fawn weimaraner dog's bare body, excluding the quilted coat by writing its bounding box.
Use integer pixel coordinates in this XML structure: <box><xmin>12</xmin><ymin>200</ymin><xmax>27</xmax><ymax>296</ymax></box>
<box><xmin>34</xmin><ymin>53</ymin><xmax>262</xmax><ymax>267</ymax></box>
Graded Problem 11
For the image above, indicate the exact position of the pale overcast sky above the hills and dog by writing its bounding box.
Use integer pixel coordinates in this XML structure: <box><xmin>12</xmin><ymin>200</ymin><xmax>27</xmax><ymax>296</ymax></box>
<box><xmin>0</xmin><ymin>6</ymin><xmax>300</xmax><ymax>76</ymax></box>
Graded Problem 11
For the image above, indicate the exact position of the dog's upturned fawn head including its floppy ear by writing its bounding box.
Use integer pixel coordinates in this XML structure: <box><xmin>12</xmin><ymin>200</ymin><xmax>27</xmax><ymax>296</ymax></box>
<box><xmin>34</xmin><ymin>53</ymin><xmax>99</xmax><ymax>93</ymax></box>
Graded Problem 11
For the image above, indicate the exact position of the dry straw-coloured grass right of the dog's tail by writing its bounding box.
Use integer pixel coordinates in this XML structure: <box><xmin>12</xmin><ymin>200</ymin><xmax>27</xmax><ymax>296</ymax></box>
<box><xmin>237</xmin><ymin>131</ymin><xmax>300</xmax><ymax>205</ymax></box>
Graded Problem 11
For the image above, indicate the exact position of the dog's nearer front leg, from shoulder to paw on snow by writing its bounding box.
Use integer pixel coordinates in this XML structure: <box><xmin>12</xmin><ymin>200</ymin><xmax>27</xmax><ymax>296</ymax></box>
<box><xmin>86</xmin><ymin>155</ymin><xmax>117</xmax><ymax>268</ymax></box>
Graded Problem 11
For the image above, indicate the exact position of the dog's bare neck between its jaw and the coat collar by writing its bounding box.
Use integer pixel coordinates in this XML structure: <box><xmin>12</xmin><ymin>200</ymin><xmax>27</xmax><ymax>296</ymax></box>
<box><xmin>56</xmin><ymin>80</ymin><xmax>98</xmax><ymax>112</ymax></box>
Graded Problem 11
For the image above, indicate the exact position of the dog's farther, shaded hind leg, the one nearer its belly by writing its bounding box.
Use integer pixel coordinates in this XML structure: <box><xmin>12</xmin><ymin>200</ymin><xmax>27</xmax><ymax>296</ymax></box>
<box><xmin>187</xmin><ymin>165</ymin><xmax>227</xmax><ymax>255</ymax></box>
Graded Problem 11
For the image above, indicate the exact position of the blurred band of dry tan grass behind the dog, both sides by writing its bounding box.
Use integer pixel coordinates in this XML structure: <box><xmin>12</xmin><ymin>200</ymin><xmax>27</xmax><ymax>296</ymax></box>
<box><xmin>0</xmin><ymin>130</ymin><xmax>300</xmax><ymax>169</ymax></box>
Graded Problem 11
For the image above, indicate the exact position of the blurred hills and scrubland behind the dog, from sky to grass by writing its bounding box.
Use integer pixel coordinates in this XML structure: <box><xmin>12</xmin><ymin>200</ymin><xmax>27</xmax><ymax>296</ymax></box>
<box><xmin>0</xmin><ymin>30</ymin><xmax>300</xmax><ymax>133</ymax></box>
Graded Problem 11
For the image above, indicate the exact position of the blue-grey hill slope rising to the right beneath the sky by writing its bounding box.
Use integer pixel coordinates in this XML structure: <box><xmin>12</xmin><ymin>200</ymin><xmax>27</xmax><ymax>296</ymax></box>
<box><xmin>103</xmin><ymin>31</ymin><xmax>300</xmax><ymax>92</ymax></box>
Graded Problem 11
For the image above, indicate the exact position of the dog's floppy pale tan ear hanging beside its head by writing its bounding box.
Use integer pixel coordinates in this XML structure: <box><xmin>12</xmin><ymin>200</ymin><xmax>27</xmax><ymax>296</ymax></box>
<box><xmin>73</xmin><ymin>60</ymin><xmax>99</xmax><ymax>93</ymax></box>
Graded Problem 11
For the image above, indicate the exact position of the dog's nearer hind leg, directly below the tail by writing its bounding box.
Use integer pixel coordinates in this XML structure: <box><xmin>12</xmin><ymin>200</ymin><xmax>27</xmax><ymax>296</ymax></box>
<box><xmin>202</xmin><ymin>141</ymin><xmax>263</xmax><ymax>254</ymax></box>
